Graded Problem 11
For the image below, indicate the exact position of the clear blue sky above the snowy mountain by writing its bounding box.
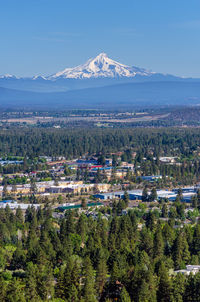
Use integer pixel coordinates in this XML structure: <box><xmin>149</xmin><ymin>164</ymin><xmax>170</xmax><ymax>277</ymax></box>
<box><xmin>0</xmin><ymin>0</ymin><xmax>200</xmax><ymax>77</ymax></box>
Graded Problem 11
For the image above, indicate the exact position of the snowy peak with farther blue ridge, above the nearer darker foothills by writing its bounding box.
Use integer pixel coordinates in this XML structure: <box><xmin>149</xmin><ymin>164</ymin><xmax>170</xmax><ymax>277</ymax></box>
<box><xmin>0</xmin><ymin>53</ymin><xmax>194</xmax><ymax>93</ymax></box>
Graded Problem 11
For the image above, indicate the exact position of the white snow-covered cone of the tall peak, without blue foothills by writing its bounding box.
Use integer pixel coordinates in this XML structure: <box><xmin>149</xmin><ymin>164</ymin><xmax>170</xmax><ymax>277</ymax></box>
<box><xmin>47</xmin><ymin>53</ymin><xmax>154</xmax><ymax>80</ymax></box>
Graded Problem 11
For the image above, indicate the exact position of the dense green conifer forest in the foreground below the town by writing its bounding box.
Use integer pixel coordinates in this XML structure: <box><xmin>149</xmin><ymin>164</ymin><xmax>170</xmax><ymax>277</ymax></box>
<box><xmin>0</xmin><ymin>203</ymin><xmax>200</xmax><ymax>302</ymax></box>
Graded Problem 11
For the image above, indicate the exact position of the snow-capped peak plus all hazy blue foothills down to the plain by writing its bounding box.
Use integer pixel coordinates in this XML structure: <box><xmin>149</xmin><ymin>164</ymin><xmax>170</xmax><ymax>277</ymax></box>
<box><xmin>0</xmin><ymin>53</ymin><xmax>200</xmax><ymax>110</ymax></box>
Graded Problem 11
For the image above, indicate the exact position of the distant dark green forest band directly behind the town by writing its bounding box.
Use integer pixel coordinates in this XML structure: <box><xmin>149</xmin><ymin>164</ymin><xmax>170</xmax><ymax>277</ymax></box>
<box><xmin>0</xmin><ymin>127</ymin><xmax>200</xmax><ymax>158</ymax></box>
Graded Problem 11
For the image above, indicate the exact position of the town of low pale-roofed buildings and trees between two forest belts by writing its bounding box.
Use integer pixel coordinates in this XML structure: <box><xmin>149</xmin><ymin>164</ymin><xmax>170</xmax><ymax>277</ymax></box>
<box><xmin>0</xmin><ymin>151</ymin><xmax>200</xmax><ymax>223</ymax></box>
